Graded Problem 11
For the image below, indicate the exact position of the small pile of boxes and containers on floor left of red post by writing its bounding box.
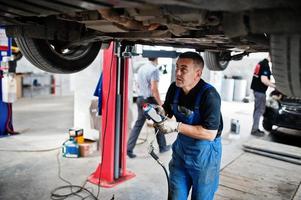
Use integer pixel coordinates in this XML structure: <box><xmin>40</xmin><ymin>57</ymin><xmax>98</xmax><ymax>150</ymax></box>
<box><xmin>63</xmin><ymin>128</ymin><xmax>97</xmax><ymax>158</ymax></box>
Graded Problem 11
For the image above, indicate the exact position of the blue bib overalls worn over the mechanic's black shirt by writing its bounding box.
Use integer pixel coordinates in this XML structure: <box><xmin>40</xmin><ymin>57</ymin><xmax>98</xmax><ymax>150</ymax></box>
<box><xmin>169</xmin><ymin>83</ymin><xmax>222</xmax><ymax>200</ymax></box>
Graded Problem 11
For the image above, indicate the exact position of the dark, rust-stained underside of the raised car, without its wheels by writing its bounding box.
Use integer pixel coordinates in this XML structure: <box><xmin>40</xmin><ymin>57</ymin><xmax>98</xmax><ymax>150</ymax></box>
<box><xmin>3</xmin><ymin>0</ymin><xmax>300</xmax><ymax>52</ymax></box>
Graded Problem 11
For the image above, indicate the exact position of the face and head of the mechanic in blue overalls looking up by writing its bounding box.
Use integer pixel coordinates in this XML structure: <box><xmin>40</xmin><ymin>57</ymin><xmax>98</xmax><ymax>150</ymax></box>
<box><xmin>176</xmin><ymin>58</ymin><xmax>202</xmax><ymax>93</ymax></box>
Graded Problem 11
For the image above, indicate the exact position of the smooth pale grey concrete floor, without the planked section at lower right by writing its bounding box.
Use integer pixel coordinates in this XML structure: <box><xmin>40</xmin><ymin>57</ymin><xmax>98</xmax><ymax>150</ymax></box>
<box><xmin>0</xmin><ymin>96</ymin><xmax>298</xmax><ymax>200</ymax></box>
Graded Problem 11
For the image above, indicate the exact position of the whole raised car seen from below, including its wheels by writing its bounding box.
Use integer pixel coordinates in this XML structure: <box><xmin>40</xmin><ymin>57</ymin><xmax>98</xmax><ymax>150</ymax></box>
<box><xmin>0</xmin><ymin>0</ymin><xmax>301</xmax><ymax>97</ymax></box>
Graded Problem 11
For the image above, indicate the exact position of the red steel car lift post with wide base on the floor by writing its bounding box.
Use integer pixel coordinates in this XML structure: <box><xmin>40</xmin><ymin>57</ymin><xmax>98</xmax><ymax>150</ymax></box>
<box><xmin>89</xmin><ymin>42</ymin><xmax>135</xmax><ymax>188</ymax></box>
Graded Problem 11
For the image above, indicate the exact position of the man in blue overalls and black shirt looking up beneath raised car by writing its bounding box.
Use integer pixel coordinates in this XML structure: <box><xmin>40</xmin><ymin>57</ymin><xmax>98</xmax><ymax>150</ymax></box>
<box><xmin>155</xmin><ymin>52</ymin><xmax>223</xmax><ymax>200</ymax></box>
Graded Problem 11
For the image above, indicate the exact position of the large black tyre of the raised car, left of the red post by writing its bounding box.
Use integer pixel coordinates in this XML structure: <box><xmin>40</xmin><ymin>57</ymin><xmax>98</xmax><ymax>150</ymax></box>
<box><xmin>15</xmin><ymin>37</ymin><xmax>101</xmax><ymax>74</ymax></box>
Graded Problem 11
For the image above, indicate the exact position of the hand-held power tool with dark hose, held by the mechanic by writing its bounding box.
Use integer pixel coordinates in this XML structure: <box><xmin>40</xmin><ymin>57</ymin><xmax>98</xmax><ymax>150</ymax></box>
<box><xmin>143</xmin><ymin>104</ymin><xmax>171</xmax><ymax>200</ymax></box>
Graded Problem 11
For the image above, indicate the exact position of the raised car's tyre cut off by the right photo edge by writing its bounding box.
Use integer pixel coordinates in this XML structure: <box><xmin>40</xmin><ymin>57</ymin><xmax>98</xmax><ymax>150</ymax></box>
<box><xmin>271</xmin><ymin>35</ymin><xmax>301</xmax><ymax>97</ymax></box>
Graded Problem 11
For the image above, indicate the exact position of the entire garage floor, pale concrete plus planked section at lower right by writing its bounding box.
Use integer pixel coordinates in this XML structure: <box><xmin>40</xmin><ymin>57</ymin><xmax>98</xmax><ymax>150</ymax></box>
<box><xmin>0</xmin><ymin>97</ymin><xmax>301</xmax><ymax>200</ymax></box>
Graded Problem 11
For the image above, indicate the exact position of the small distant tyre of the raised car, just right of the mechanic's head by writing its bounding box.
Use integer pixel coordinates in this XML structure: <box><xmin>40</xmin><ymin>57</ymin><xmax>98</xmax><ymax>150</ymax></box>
<box><xmin>204</xmin><ymin>51</ymin><xmax>229</xmax><ymax>71</ymax></box>
